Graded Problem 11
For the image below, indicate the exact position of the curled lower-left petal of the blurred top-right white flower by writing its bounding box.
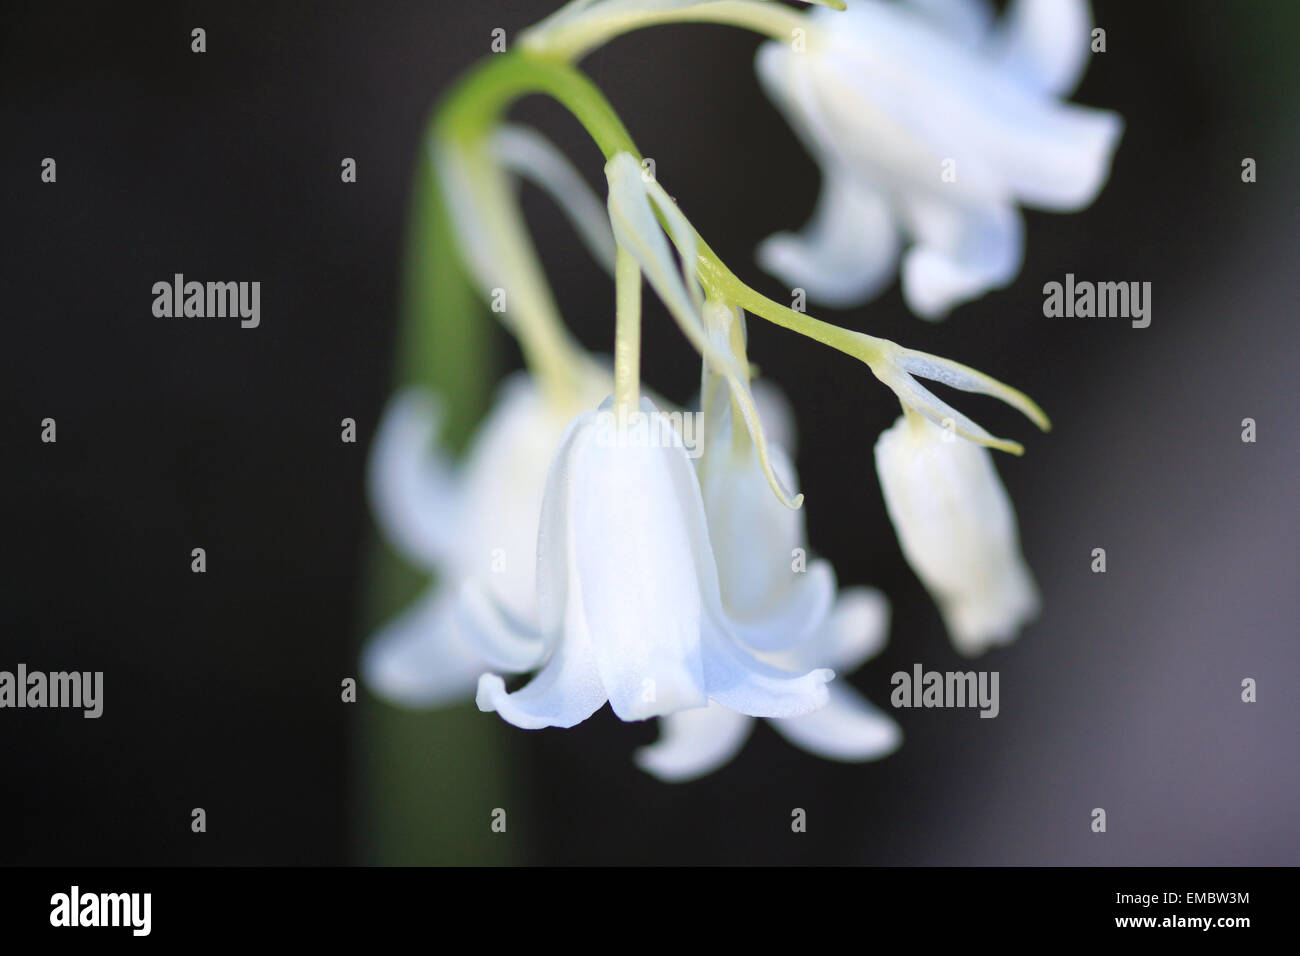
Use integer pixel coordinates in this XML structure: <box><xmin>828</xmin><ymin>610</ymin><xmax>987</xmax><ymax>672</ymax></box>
<box><xmin>758</xmin><ymin>165</ymin><xmax>900</xmax><ymax>307</ymax></box>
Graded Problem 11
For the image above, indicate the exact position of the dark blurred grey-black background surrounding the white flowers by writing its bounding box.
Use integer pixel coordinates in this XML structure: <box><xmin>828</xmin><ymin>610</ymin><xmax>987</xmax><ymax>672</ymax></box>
<box><xmin>0</xmin><ymin>0</ymin><xmax>1300</xmax><ymax>864</ymax></box>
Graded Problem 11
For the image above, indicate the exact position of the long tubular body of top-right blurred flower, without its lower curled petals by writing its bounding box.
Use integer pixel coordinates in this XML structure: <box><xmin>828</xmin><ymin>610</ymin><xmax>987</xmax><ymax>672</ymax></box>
<box><xmin>759</xmin><ymin>3</ymin><xmax>1122</xmax><ymax>217</ymax></box>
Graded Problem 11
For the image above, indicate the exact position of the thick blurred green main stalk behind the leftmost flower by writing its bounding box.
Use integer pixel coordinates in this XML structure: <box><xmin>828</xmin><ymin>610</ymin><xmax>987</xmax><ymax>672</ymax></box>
<box><xmin>355</xmin><ymin>127</ymin><xmax>515</xmax><ymax>865</ymax></box>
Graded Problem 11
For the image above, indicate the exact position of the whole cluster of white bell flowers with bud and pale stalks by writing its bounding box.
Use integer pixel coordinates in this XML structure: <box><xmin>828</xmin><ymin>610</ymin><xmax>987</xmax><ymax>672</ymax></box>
<box><xmin>364</xmin><ymin>0</ymin><xmax>1118</xmax><ymax>780</ymax></box>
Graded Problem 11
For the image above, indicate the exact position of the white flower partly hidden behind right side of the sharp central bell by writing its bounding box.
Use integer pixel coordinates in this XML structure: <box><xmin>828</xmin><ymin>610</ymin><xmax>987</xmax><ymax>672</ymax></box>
<box><xmin>637</xmin><ymin>376</ymin><xmax>901</xmax><ymax>782</ymax></box>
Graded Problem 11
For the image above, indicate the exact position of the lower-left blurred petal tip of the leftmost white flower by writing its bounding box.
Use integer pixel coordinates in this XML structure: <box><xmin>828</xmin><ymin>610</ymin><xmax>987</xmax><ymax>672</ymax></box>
<box><xmin>361</xmin><ymin>585</ymin><xmax>486</xmax><ymax>708</ymax></box>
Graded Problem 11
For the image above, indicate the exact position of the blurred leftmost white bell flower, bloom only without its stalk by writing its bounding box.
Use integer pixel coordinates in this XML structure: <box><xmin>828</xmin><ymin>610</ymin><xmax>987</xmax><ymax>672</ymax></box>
<box><xmin>363</xmin><ymin>369</ymin><xmax>608</xmax><ymax>706</ymax></box>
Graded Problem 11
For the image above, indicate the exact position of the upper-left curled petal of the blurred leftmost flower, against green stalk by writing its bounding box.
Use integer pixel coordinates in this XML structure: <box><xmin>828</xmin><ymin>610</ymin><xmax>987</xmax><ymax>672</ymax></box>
<box><xmin>367</xmin><ymin>388</ymin><xmax>459</xmax><ymax>568</ymax></box>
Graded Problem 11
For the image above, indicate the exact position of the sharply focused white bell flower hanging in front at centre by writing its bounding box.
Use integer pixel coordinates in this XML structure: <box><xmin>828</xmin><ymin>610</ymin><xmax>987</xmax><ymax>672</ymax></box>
<box><xmin>477</xmin><ymin>398</ymin><xmax>833</xmax><ymax>728</ymax></box>
